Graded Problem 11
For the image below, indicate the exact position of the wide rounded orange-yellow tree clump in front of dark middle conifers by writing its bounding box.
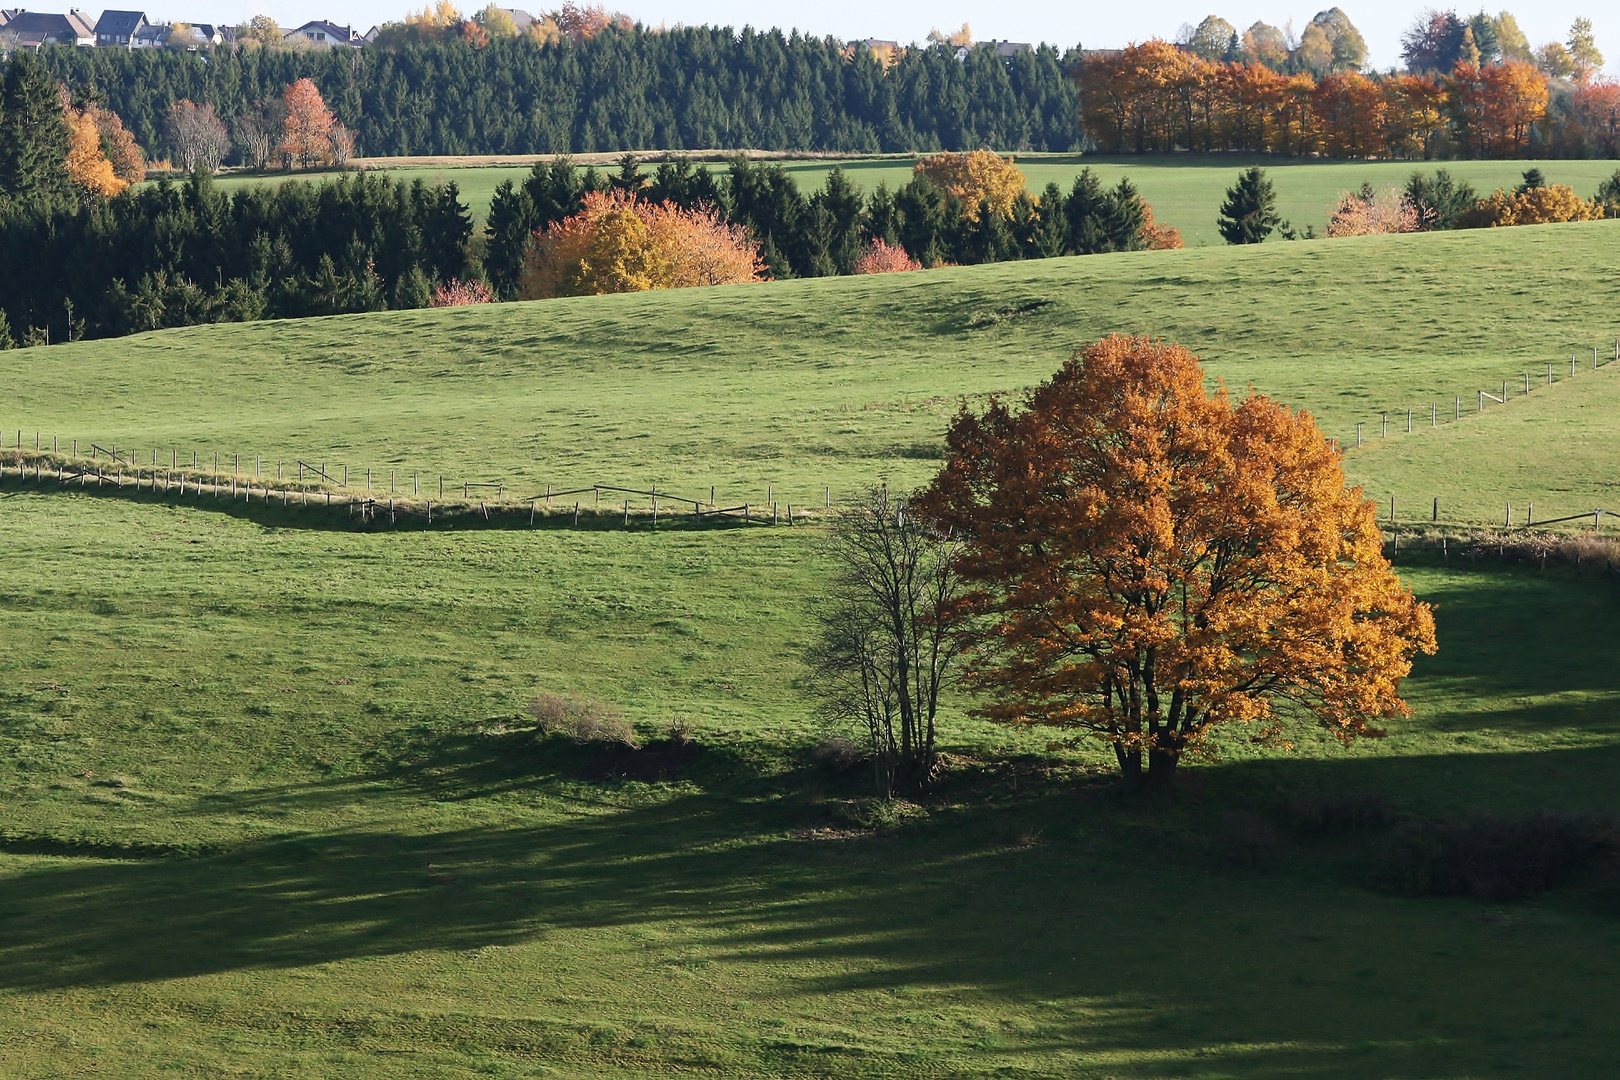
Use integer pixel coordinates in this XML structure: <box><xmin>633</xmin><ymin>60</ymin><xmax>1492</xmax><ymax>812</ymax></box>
<box><xmin>518</xmin><ymin>189</ymin><xmax>765</xmax><ymax>300</ymax></box>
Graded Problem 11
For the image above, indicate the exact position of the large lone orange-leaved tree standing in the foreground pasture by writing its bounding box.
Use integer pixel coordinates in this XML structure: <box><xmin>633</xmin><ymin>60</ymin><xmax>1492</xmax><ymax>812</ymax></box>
<box><xmin>922</xmin><ymin>337</ymin><xmax>1435</xmax><ymax>785</ymax></box>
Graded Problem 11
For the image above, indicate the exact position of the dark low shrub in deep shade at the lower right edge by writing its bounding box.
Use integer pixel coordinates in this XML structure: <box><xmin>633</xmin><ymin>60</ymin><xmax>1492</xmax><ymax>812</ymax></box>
<box><xmin>1377</xmin><ymin>811</ymin><xmax>1615</xmax><ymax>900</ymax></box>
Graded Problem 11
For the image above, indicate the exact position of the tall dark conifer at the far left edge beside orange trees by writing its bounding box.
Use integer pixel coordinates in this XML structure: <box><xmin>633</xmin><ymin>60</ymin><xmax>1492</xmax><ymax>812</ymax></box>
<box><xmin>0</xmin><ymin>50</ymin><xmax>73</xmax><ymax>209</ymax></box>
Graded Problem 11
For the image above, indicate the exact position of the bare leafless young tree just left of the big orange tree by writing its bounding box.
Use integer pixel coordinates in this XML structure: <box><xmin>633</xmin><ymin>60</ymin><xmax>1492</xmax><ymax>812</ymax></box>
<box><xmin>807</xmin><ymin>487</ymin><xmax>959</xmax><ymax>795</ymax></box>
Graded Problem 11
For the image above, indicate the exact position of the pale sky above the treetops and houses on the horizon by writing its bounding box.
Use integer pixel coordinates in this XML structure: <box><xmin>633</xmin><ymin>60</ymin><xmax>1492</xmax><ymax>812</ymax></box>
<box><xmin>136</xmin><ymin>0</ymin><xmax>1620</xmax><ymax>73</ymax></box>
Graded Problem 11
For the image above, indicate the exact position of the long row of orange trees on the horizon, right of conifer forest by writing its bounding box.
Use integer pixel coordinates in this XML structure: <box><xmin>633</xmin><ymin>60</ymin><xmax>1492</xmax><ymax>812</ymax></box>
<box><xmin>1079</xmin><ymin>40</ymin><xmax>1547</xmax><ymax>157</ymax></box>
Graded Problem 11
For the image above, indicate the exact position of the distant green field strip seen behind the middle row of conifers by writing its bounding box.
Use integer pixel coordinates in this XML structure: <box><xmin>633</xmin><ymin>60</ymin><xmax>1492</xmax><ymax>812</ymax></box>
<box><xmin>202</xmin><ymin>154</ymin><xmax>1617</xmax><ymax>248</ymax></box>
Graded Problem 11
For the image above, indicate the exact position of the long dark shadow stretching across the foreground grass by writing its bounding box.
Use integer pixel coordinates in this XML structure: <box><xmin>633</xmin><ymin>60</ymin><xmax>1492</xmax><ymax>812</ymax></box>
<box><xmin>0</xmin><ymin>748</ymin><xmax>1620</xmax><ymax>1078</ymax></box>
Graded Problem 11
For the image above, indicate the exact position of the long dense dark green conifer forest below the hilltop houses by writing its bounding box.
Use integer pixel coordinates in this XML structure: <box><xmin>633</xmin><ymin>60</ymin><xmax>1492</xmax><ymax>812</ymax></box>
<box><xmin>31</xmin><ymin>26</ymin><xmax>1085</xmax><ymax>157</ymax></box>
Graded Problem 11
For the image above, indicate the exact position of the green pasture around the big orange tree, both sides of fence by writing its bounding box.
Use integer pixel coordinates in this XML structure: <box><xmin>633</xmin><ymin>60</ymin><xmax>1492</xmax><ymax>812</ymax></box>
<box><xmin>0</xmin><ymin>216</ymin><xmax>1620</xmax><ymax>1080</ymax></box>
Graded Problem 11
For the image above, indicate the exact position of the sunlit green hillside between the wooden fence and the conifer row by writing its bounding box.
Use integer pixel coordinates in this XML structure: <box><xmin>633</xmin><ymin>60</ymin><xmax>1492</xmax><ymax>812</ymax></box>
<box><xmin>9</xmin><ymin>222</ymin><xmax>1620</xmax><ymax>513</ymax></box>
